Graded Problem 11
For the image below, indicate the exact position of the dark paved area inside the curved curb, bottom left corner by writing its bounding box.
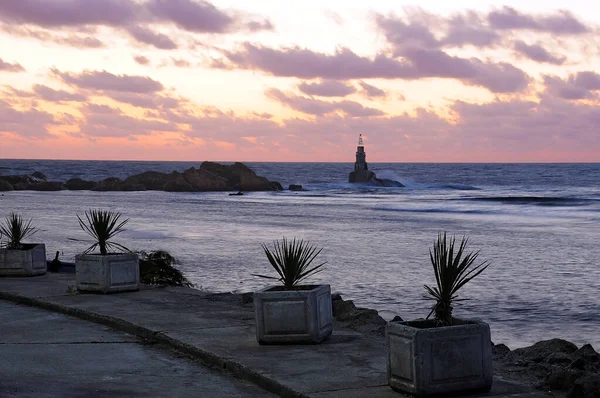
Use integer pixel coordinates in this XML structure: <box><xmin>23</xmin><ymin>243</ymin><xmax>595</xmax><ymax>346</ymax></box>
<box><xmin>0</xmin><ymin>301</ymin><xmax>274</xmax><ymax>398</ymax></box>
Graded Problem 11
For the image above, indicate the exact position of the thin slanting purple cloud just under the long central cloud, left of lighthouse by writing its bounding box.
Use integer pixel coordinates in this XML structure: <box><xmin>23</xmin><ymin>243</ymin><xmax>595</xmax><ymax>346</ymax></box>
<box><xmin>265</xmin><ymin>88</ymin><xmax>384</xmax><ymax>117</ymax></box>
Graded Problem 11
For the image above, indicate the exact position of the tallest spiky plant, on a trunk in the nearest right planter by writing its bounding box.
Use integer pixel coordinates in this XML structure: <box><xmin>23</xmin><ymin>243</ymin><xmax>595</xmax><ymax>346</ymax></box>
<box><xmin>425</xmin><ymin>232</ymin><xmax>490</xmax><ymax>326</ymax></box>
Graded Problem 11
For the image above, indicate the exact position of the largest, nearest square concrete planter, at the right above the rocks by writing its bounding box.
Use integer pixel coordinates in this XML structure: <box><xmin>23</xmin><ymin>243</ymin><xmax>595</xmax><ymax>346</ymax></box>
<box><xmin>386</xmin><ymin>318</ymin><xmax>492</xmax><ymax>396</ymax></box>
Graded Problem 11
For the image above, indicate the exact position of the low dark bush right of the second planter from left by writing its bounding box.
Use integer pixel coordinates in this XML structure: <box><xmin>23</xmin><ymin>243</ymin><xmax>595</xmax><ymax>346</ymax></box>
<box><xmin>139</xmin><ymin>250</ymin><xmax>194</xmax><ymax>287</ymax></box>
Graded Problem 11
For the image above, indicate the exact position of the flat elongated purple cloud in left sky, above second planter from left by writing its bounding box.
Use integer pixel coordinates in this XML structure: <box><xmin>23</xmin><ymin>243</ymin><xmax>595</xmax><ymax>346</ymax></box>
<box><xmin>52</xmin><ymin>69</ymin><xmax>163</xmax><ymax>93</ymax></box>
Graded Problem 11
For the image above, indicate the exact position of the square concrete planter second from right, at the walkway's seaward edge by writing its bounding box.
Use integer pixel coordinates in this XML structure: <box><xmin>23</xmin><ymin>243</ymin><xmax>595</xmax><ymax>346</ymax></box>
<box><xmin>254</xmin><ymin>285</ymin><xmax>333</xmax><ymax>344</ymax></box>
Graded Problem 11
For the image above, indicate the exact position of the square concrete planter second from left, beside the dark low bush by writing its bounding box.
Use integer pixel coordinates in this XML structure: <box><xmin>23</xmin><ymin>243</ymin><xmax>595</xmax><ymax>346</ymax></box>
<box><xmin>75</xmin><ymin>253</ymin><xmax>140</xmax><ymax>293</ymax></box>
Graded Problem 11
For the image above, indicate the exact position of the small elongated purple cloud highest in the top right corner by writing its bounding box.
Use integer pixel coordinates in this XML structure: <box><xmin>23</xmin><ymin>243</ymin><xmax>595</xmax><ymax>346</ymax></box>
<box><xmin>488</xmin><ymin>7</ymin><xmax>591</xmax><ymax>35</ymax></box>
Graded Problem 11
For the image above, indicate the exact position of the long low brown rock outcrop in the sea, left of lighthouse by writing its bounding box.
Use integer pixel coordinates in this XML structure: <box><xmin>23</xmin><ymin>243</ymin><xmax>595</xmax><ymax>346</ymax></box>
<box><xmin>0</xmin><ymin>162</ymin><xmax>283</xmax><ymax>192</ymax></box>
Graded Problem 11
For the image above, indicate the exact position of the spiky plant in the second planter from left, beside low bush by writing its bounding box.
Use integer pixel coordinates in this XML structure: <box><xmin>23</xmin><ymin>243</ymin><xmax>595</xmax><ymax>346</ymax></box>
<box><xmin>77</xmin><ymin>209</ymin><xmax>130</xmax><ymax>255</ymax></box>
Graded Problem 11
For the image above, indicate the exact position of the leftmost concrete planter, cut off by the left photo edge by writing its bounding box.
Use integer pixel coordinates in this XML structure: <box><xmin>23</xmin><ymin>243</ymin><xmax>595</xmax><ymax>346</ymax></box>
<box><xmin>0</xmin><ymin>243</ymin><xmax>47</xmax><ymax>276</ymax></box>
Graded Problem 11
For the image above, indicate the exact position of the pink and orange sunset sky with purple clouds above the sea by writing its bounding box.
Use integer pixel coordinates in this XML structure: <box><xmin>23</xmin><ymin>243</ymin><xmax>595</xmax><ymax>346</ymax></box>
<box><xmin>0</xmin><ymin>0</ymin><xmax>600</xmax><ymax>162</ymax></box>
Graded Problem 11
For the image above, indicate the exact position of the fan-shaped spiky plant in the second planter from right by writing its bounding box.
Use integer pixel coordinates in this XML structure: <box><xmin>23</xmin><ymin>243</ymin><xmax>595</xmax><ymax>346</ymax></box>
<box><xmin>254</xmin><ymin>237</ymin><xmax>327</xmax><ymax>290</ymax></box>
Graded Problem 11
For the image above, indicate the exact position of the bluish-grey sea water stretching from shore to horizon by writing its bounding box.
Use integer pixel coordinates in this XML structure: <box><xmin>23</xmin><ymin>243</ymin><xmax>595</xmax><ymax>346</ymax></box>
<box><xmin>0</xmin><ymin>159</ymin><xmax>600</xmax><ymax>349</ymax></box>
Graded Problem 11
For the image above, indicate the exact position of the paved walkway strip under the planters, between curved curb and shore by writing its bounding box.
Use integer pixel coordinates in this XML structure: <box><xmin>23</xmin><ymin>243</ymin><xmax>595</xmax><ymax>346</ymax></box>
<box><xmin>0</xmin><ymin>274</ymin><xmax>552</xmax><ymax>398</ymax></box>
